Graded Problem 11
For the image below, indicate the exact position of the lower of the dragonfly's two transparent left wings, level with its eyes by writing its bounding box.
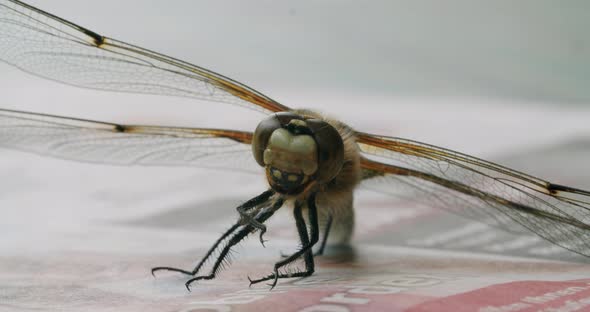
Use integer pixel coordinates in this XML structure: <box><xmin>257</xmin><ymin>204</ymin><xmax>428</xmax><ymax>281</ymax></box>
<box><xmin>0</xmin><ymin>109</ymin><xmax>260</xmax><ymax>172</ymax></box>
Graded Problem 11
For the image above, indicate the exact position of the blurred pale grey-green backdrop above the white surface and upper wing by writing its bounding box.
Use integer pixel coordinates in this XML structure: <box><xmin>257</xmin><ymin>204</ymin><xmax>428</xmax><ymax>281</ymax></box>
<box><xmin>15</xmin><ymin>0</ymin><xmax>590</xmax><ymax>105</ymax></box>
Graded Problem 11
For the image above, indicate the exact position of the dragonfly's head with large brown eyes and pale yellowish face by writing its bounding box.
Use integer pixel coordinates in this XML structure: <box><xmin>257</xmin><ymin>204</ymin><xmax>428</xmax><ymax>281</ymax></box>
<box><xmin>252</xmin><ymin>112</ymin><xmax>344</xmax><ymax>195</ymax></box>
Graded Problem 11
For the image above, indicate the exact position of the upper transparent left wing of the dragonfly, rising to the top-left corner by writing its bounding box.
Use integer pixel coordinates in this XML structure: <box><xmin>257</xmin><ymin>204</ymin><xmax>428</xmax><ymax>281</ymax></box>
<box><xmin>0</xmin><ymin>0</ymin><xmax>288</xmax><ymax>113</ymax></box>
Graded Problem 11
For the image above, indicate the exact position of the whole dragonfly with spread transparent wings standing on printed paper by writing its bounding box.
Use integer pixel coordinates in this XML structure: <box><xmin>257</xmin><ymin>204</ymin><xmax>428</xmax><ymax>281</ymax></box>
<box><xmin>0</xmin><ymin>0</ymin><xmax>590</xmax><ymax>290</ymax></box>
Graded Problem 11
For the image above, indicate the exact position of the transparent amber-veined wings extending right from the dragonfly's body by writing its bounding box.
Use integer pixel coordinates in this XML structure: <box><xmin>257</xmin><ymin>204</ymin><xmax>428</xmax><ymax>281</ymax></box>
<box><xmin>357</xmin><ymin>133</ymin><xmax>590</xmax><ymax>257</ymax></box>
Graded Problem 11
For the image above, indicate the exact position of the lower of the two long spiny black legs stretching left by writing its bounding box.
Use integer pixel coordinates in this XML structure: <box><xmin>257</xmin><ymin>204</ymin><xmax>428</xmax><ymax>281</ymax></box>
<box><xmin>185</xmin><ymin>198</ymin><xmax>284</xmax><ymax>291</ymax></box>
